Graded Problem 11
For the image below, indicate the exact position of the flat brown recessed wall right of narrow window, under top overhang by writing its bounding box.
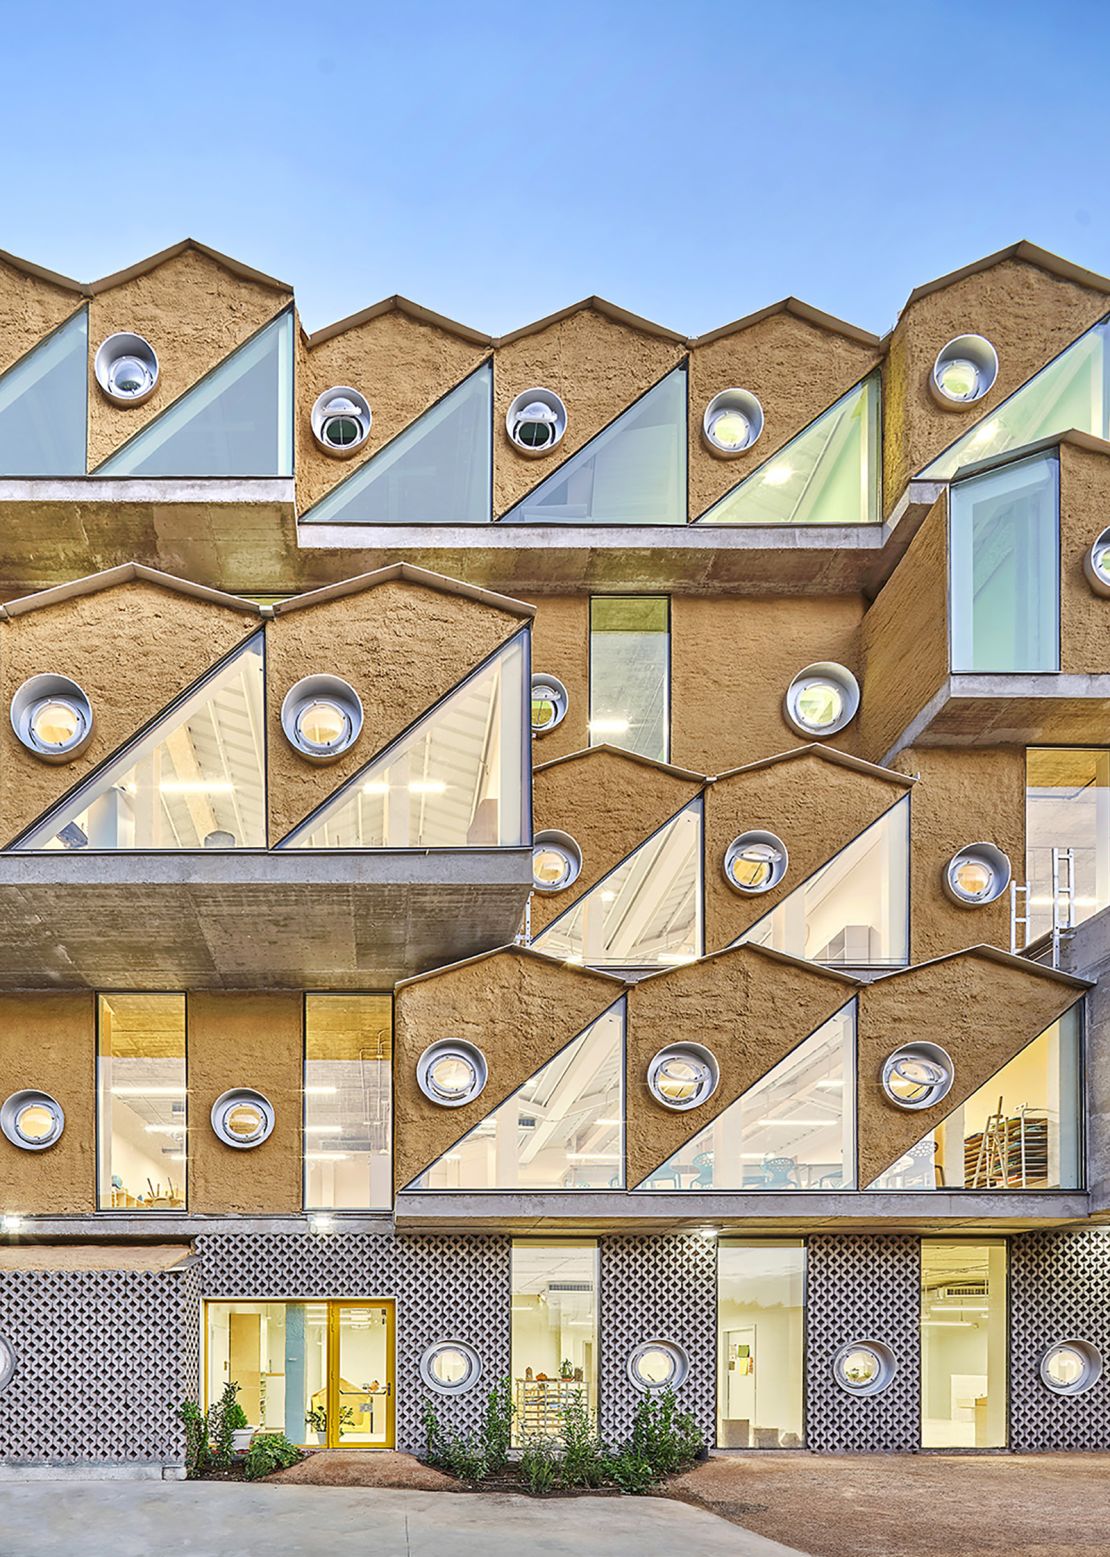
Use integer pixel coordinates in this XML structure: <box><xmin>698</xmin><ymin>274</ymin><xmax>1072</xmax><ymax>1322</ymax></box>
<box><xmin>671</xmin><ymin>595</ymin><xmax>867</xmax><ymax>774</ymax></box>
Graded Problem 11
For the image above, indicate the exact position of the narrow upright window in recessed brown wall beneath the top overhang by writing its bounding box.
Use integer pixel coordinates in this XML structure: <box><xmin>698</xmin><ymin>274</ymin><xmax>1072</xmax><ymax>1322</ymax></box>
<box><xmin>590</xmin><ymin>595</ymin><xmax>671</xmax><ymax>763</ymax></box>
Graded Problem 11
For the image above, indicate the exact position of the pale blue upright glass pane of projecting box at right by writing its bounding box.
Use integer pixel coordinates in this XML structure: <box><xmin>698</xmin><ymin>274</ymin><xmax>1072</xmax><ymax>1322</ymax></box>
<box><xmin>950</xmin><ymin>455</ymin><xmax>1060</xmax><ymax>673</ymax></box>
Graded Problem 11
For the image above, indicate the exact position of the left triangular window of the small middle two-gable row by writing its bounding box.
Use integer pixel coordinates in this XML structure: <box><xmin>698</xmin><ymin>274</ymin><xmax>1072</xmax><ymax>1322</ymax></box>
<box><xmin>532</xmin><ymin>800</ymin><xmax>704</xmax><ymax>968</ymax></box>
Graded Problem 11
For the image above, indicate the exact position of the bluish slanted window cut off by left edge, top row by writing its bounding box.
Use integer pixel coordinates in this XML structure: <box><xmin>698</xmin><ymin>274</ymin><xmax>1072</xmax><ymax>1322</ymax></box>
<box><xmin>0</xmin><ymin>308</ymin><xmax>89</xmax><ymax>476</ymax></box>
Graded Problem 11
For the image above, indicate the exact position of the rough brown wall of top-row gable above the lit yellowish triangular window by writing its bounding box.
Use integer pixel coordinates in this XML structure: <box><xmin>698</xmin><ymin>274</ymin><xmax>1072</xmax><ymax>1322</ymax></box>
<box><xmin>690</xmin><ymin>311</ymin><xmax>880</xmax><ymax>518</ymax></box>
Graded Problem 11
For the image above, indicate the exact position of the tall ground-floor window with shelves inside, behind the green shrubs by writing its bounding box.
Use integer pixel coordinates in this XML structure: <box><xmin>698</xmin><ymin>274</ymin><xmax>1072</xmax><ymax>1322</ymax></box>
<box><xmin>511</xmin><ymin>1238</ymin><xmax>598</xmax><ymax>1443</ymax></box>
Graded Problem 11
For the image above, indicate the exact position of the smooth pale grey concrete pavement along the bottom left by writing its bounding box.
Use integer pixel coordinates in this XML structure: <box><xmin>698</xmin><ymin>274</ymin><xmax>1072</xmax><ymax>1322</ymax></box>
<box><xmin>0</xmin><ymin>1481</ymin><xmax>805</xmax><ymax>1557</ymax></box>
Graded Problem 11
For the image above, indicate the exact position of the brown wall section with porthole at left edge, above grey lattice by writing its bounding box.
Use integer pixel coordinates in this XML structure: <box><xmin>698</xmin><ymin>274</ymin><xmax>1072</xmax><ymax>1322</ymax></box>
<box><xmin>0</xmin><ymin>993</ymin><xmax>97</xmax><ymax>1216</ymax></box>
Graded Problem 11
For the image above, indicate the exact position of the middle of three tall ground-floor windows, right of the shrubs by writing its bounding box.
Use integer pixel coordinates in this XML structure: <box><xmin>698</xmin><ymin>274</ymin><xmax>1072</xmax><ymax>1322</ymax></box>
<box><xmin>716</xmin><ymin>1239</ymin><xmax>805</xmax><ymax>1450</ymax></box>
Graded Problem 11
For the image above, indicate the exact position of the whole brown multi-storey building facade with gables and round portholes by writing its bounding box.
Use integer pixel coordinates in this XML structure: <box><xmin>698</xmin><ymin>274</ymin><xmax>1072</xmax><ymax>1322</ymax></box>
<box><xmin>0</xmin><ymin>241</ymin><xmax>1110</xmax><ymax>1474</ymax></box>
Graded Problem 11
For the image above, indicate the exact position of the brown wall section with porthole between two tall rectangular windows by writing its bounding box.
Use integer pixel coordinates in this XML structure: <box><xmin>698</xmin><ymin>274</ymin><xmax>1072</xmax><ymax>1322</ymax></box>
<box><xmin>187</xmin><ymin>993</ymin><xmax>304</xmax><ymax>1216</ymax></box>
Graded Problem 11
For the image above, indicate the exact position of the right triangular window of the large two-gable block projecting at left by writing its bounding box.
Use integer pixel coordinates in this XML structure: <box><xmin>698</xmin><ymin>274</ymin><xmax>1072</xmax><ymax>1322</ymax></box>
<box><xmin>279</xmin><ymin>632</ymin><xmax>531</xmax><ymax>849</ymax></box>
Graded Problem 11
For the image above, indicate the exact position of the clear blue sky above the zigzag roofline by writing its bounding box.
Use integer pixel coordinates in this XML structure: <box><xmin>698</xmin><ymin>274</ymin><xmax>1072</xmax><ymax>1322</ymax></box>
<box><xmin>0</xmin><ymin>0</ymin><xmax>1110</xmax><ymax>333</ymax></box>
